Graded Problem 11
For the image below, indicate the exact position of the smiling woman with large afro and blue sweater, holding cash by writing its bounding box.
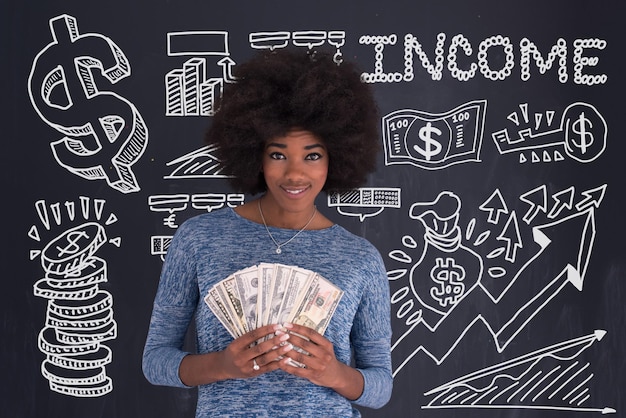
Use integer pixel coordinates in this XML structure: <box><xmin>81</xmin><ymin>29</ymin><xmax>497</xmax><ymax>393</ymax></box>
<box><xmin>143</xmin><ymin>50</ymin><xmax>392</xmax><ymax>417</ymax></box>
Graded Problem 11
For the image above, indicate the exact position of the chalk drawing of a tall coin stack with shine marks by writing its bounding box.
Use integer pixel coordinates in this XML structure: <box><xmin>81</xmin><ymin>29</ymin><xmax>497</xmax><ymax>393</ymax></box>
<box><xmin>28</xmin><ymin>197</ymin><xmax>121</xmax><ymax>397</ymax></box>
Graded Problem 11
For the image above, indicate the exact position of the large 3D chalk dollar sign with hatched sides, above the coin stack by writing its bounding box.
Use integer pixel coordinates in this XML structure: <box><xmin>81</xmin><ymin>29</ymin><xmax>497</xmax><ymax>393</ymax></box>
<box><xmin>28</xmin><ymin>15</ymin><xmax>148</xmax><ymax>193</ymax></box>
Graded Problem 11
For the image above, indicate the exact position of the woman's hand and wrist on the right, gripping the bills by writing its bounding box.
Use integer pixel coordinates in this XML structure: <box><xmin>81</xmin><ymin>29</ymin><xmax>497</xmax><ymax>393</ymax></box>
<box><xmin>279</xmin><ymin>324</ymin><xmax>363</xmax><ymax>400</ymax></box>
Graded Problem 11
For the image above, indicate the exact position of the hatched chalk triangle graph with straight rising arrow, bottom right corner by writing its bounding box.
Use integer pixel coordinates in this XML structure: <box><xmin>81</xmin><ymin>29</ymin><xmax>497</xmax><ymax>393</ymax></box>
<box><xmin>422</xmin><ymin>330</ymin><xmax>616</xmax><ymax>414</ymax></box>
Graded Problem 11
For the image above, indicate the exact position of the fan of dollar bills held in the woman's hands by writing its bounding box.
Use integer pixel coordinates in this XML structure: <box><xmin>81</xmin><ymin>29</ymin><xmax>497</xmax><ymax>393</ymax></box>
<box><xmin>204</xmin><ymin>263</ymin><xmax>343</xmax><ymax>338</ymax></box>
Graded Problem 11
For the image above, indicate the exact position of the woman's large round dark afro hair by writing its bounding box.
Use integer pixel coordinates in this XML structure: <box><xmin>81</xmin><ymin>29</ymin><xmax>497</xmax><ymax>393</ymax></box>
<box><xmin>205</xmin><ymin>49</ymin><xmax>381</xmax><ymax>194</ymax></box>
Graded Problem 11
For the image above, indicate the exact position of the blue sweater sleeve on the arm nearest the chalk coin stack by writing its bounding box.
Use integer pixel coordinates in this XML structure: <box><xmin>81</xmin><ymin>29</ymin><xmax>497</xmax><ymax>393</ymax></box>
<box><xmin>142</xmin><ymin>224</ymin><xmax>199</xmax><ymax>387</ymax></box>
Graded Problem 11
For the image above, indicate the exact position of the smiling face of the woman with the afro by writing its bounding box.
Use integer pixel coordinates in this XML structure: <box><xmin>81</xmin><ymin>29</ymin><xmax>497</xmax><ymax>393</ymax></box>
<box><xmin>263</xmin><ymin>130</ymin><xmax>328</xmax><ymax>214</ymax></box>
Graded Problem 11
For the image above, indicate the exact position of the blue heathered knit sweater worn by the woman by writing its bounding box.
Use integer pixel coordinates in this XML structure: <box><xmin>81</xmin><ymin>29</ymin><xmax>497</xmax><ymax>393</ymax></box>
<box><xmin>143</xmin><ymin>208</ymin><xmax>392</xmax><ymax>417</ymax></box>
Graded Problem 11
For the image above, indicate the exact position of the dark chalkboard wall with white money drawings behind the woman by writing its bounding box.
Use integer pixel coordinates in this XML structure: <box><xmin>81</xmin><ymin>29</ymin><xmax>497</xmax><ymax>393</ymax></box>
<box><xmin>0</xmin><ymin>0</ymin><xmax>626</xmax><ymax>417</ymax></box>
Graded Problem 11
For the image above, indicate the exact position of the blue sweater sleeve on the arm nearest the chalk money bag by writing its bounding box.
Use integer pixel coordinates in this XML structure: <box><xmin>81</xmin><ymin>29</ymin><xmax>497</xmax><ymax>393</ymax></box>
<box><xmin>351</xmin><ymin>248</ymin><xmax>393</xmax><ymax>408</ymax></box>
